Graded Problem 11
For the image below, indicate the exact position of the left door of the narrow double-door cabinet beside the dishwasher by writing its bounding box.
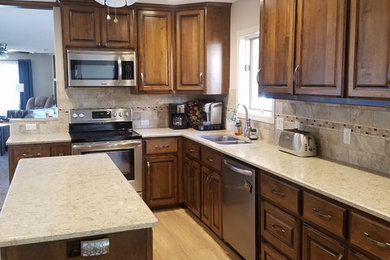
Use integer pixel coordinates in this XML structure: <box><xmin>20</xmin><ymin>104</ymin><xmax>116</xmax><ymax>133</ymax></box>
<box><xmin>200</xmin><ymin>167</ymin><xmax>212</xmax><ymax>226</ymax></box>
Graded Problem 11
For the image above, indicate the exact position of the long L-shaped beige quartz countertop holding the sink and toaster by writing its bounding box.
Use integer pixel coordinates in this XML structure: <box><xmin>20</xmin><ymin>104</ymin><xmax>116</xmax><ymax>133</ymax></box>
<box><xmin>136</xmin><ymin>128</ymin><xmax>390</xmax><ymax>222</ymax></box>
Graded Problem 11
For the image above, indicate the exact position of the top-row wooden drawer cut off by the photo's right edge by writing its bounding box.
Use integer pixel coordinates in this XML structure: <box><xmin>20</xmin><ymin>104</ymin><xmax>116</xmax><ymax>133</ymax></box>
<box><xmin>349</xmin><ymin>212</ymin><xmax>390</xmax><ymax>259</ymax></box>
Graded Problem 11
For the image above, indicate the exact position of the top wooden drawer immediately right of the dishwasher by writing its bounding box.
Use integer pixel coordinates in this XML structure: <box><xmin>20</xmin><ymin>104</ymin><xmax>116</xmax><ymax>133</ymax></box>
<box><xmin>260</xmin><ymin>174</ymin><xmax>299</xmax><ymax>214</ymax></box>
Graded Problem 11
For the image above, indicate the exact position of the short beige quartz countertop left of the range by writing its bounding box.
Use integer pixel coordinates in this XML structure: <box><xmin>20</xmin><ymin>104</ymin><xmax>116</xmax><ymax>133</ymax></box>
<box><xmin>7</xmin><ymin>133</ymin><xmax>71</xmax><ymax>145</ymax></box>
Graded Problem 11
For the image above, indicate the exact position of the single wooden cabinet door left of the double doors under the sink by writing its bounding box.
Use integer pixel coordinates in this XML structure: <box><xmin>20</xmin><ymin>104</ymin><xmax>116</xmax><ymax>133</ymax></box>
<box><xmin>184</xmin><ymin>157</ymin><xmax>200</xmax><ymax>217</ymax></box>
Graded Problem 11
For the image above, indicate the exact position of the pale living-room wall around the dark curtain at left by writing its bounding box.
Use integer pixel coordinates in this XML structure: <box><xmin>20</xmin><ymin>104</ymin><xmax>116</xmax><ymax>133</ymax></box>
<box><xmin>4</xmin><ymin>53</ymin><xmax>54</xmax><ymax>97</ymax></box>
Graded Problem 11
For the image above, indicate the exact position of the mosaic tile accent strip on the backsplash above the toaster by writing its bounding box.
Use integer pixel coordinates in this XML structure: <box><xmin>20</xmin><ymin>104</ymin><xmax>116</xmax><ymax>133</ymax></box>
<box><xmin>275</xmin><ymin>114</ymin><xmax>390</xmax><ymax>139</ymax></box>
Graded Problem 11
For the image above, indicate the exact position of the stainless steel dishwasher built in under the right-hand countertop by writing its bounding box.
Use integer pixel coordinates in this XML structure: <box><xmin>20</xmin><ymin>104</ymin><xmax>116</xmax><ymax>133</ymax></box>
<box><xmin>222</xmin><ymin>158</ymin><xmax>256</xmax><ymax>260</ymax></box>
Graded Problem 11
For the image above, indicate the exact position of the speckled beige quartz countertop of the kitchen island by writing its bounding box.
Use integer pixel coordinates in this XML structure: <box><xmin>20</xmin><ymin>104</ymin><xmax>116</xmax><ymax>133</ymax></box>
<box><xmin>0</xmin><ymin>154</ymin><xmax>157</xmax><ymax>247</ymax></box>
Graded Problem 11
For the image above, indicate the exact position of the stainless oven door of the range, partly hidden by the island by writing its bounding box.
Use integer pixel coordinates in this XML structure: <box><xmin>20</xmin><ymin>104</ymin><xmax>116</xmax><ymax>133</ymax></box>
<box><xmin>72</xmin><ymin>140</ymin><xmax>142</xmax><ymax>192</ymax></box>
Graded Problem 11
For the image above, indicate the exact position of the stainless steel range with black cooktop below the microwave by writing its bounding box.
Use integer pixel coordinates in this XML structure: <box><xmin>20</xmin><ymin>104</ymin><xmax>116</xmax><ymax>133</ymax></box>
<box><xmin>69</xmin><ymin>109</ymin><xmax>142</xmax><ymax>193</ymax></box>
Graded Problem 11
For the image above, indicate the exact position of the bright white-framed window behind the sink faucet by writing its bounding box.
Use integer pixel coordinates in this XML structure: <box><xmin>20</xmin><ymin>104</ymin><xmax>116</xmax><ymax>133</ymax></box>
<box><xmin>237</xmin><ymin>32</ymin><xmax>274</xmax><ymax>124</ymax></box>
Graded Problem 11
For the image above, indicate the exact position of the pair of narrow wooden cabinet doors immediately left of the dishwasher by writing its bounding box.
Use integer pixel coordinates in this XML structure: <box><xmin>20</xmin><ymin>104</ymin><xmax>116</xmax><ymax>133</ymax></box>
<box><xmin>201</xmin><ymin>167</ymin><xmax>222</xmax><ymax>237</ymax></box>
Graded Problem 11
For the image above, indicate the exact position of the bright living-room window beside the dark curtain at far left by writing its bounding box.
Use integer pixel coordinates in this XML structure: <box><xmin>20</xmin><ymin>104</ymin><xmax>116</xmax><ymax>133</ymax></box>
<box><xmin>0</xmin><ymin>61</ymin><xmax>20</xmax><ymax>115</ymax></box>
